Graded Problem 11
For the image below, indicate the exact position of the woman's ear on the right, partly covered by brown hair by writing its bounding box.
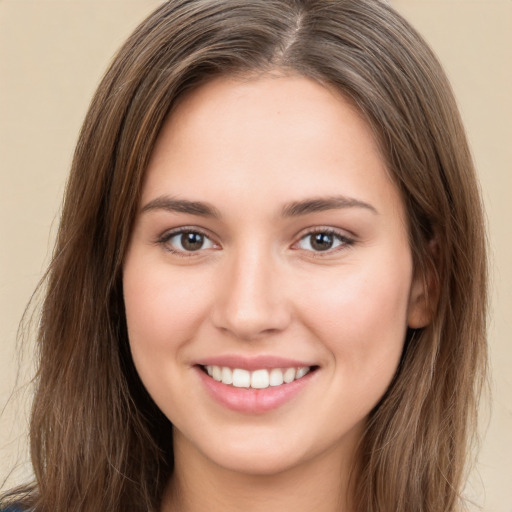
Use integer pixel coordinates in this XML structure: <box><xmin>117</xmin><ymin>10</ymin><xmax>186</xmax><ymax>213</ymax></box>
<box><xmin>407</xmin><ymin>239</ymin><xmax>439</xmax><ymax>329</ymax></box>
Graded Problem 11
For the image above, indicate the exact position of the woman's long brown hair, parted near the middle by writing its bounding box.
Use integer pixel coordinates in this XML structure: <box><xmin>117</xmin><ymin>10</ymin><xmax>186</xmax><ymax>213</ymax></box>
<box><xmin>4</xmin><ymin>0</ymin><xmax>486</xmax><ymax>512</ymax></box>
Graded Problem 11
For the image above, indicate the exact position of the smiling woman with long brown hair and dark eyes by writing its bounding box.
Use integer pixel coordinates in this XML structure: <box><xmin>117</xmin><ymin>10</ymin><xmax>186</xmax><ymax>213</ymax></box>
<box><xmin>0</xmin><ymin>0</ymin><xmax>486</xmax><ymax>512</ymax></box>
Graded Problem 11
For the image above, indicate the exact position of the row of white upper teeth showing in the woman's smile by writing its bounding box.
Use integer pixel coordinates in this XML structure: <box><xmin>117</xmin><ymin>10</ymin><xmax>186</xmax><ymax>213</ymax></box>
<box><xmin>205</xmin><ymin>365</ymin><xmax>311</xmax><ymax>389</ymax></box>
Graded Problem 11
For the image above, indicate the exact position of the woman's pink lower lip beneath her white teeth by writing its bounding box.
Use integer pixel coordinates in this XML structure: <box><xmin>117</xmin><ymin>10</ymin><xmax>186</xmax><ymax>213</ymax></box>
<box><xmin>197</xmin><ymin>368</ymin><xmax>316</xmax><ymax>414</ymax></box>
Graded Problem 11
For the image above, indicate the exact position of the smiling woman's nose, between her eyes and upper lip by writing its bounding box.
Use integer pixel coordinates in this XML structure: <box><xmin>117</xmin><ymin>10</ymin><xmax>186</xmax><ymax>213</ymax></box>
<box><xmin>212</xmin><ymin>247</ymin><xmax>292</xmax><ymax>341</ymax></box>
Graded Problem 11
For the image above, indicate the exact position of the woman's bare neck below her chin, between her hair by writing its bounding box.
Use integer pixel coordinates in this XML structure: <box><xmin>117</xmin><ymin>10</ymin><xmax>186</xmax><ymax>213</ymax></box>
<box><xmin>161</xmin><ymin>428</ymin><xmax>354</xmax><ymax>512</ymax></box>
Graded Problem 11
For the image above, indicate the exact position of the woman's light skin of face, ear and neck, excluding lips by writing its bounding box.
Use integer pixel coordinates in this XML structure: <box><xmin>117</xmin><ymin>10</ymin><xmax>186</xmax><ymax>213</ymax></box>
<box><xmin>123</xmin><ymin>74</ymin><xmax>428</xmax><ymax>512</ymax></box>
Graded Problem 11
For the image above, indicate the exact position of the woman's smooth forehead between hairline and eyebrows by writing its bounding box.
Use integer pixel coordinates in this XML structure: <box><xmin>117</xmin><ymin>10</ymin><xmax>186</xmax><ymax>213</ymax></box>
<box><xmin>143</xmin><ymin>75</ymin><xmax>399</xmax><ymax>221</ymax></box>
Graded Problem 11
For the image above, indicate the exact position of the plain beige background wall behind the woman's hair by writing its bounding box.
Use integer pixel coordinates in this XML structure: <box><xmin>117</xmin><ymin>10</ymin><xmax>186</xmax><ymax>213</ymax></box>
<box><xmin>0</xmin><ymin>0</ymin><xmax>512</xmax><ymax>512</ymax></box>
